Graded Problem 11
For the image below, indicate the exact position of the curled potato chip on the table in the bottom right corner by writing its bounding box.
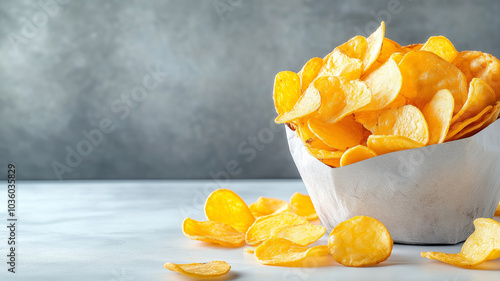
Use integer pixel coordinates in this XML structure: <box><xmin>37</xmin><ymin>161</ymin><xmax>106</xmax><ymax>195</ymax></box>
<box><xmin>420</xmin><ymin>218</ymin><xmax>500</xmax><ymax>267</ymax></box>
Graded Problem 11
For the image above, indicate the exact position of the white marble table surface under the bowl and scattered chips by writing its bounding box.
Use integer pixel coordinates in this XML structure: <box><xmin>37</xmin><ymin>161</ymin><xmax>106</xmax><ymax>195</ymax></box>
<box><xmin>0</xmin><ymin>180</ymin><xmax>500</xmax><ymax>281</ymax></box>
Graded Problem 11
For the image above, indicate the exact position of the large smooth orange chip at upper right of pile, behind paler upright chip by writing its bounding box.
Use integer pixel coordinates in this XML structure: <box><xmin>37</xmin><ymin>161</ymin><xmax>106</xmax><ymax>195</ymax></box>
<box><xmin>399</xmin><ymin>51</ymin><xmax>467</xmax><ymax>113</ymax></box>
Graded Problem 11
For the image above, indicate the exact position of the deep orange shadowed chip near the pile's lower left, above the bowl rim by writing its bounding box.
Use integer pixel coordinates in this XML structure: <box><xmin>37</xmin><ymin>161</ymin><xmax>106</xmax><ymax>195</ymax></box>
<box><xmin>307</xmin><ymin>116</ymin><xmax>363</xmax><ymax>151</ymax></box>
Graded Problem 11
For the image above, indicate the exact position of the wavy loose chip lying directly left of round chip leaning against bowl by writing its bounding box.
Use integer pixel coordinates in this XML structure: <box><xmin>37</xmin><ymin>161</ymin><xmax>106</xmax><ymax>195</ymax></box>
<box><xmin>255</xmin><ymin>238</ymin><xmax>328</xmax><ymax>266</ymax></box>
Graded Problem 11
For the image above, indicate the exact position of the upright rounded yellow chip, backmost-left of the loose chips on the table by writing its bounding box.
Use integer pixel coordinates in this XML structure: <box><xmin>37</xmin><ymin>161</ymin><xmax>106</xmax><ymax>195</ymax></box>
<box><xmin>205</xmin><ymin>189</ymin><xmax>255</xmax><ymax>232</ymax></box>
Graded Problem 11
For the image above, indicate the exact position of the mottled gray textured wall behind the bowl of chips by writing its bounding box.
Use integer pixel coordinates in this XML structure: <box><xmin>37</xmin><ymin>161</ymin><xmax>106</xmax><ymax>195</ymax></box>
<box><xmin>0</xmin><ymin>0</ymin><xmax>500</xmax><ymax>179</ymax></box>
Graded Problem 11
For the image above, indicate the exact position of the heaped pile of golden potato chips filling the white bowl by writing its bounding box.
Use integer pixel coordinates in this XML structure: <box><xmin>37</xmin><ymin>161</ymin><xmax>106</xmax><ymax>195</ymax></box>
<box><xmin>274</xmin><ymin>22</ymin><xmax>500</xmax><ymax>167</ymax></box>
